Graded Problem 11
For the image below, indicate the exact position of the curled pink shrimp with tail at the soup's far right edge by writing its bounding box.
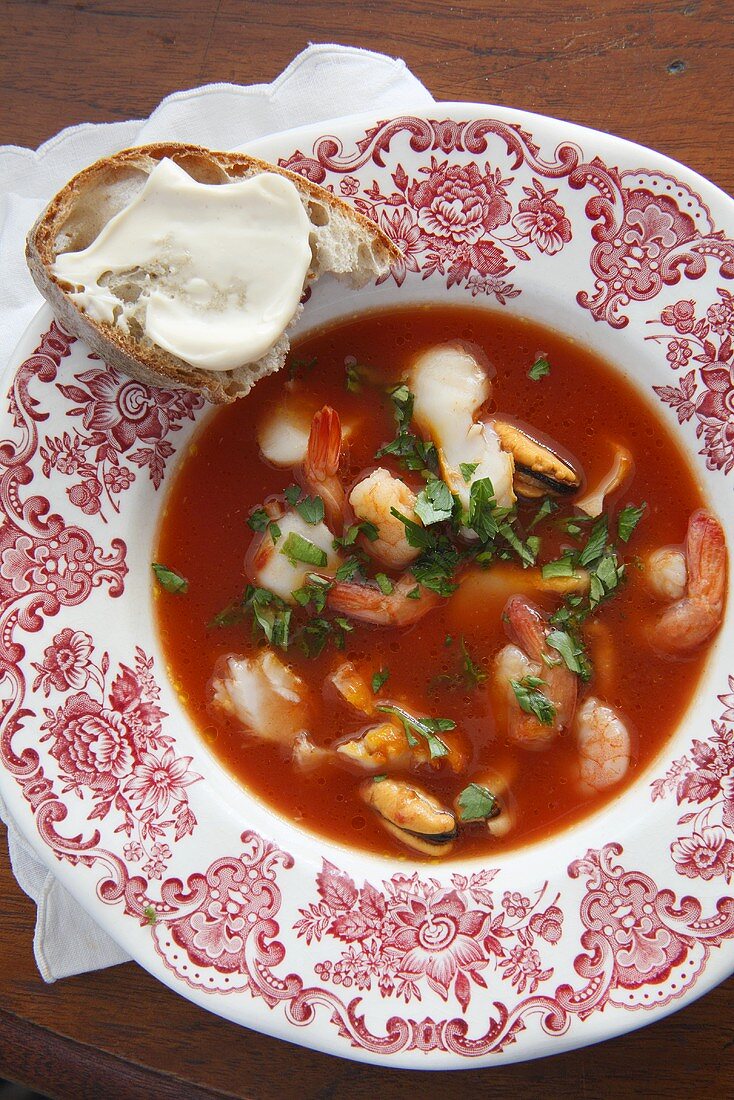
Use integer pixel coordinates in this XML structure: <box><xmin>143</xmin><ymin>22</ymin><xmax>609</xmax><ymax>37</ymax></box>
<box><xmin>650</xmin><ymin>510</ymin><xmax>726</xmax><ymax>657</ymax></box>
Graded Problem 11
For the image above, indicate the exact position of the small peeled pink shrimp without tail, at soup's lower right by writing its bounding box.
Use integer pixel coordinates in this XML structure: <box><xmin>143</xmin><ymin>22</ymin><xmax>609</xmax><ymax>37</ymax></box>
<box><xmin>576</xmin><ymin>695</ymin><xmax>632</xmax><ymax>794</ymax></box>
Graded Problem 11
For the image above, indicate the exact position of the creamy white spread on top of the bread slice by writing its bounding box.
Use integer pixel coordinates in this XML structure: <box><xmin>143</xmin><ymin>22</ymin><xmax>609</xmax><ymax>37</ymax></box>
<box><xmin>53</xmin><ymin>160</ymin><xmax>311</xmax><ymax>371</ymax></box>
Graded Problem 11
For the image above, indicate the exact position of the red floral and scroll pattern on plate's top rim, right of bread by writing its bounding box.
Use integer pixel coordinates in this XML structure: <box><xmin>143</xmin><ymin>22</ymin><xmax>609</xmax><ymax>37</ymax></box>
<box><xmin>280</xmin><ymin>116</ymin><xmax>734</xmax><ymax>328</ymax></box>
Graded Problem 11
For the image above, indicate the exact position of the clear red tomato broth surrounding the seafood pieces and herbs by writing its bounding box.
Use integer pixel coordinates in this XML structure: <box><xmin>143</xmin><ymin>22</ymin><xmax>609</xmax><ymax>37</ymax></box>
<box><xmin>156</xmin><ymin>305</ymin><xmax>705</xmax><ymax>858</ymax></box>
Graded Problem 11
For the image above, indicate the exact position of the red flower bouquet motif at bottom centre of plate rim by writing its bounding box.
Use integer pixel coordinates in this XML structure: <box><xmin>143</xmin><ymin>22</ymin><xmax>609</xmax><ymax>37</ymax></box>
<box><xmin>295</xmin><ymin>860</ymin><xmax>554</xmax><ymax>1012</ymax></box>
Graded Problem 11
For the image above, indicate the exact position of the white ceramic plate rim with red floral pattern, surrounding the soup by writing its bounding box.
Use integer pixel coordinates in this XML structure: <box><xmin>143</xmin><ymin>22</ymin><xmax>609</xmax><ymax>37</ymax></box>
<box><xmin>0</xmin><ymin>103</ymin><xmax>734</xmax><ymax>1069</ymax></box>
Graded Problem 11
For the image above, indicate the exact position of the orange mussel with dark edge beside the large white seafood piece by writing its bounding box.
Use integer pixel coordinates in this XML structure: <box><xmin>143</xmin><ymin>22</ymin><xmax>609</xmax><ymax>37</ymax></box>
<box><xmin>492</xmin><ymin>419</ymin><xmax>581</xmax><ymax>499</ymax></box>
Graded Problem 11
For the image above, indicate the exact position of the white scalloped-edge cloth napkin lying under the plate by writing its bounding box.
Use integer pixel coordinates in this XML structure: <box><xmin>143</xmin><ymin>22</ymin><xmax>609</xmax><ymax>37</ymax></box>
<box><xmin>0</xmin><ymin>45</ymin><xmax>434</xmax><ymax>981</ymax></box>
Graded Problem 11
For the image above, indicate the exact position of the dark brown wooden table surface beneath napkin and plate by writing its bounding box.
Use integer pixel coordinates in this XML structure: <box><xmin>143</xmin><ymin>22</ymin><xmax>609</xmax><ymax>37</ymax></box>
<box><xmin>0</xmin><ymin>0</ymin><xmax>734</xmax><ymax>1100</ymax></box>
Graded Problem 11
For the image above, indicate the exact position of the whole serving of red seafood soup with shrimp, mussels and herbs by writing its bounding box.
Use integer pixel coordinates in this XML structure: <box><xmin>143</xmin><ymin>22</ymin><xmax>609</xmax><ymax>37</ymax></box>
<box><xmin>156</xmin><ymin>305</ymin><xmax>727</xmax><ymax>860</ymax></box>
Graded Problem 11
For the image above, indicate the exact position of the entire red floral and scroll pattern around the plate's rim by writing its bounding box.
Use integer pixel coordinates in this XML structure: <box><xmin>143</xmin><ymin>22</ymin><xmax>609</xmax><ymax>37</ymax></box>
<box><xmin>0</xmin><ymin>107</ymin><xmax>734</xmax><ymax>1065</ymax></box>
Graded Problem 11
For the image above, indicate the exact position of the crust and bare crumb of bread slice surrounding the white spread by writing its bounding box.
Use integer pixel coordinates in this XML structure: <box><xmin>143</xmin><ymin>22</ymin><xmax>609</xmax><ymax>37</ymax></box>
<box><xmin>25</xmin><ymin>143</ymin><xmax>401</xmax><ymax>404</ymax></box>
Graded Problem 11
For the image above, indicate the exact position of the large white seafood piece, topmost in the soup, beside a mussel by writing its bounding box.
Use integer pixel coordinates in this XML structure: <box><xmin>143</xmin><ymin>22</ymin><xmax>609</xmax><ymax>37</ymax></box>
<box><xmin>409</xmin><ymin>341</ymin><xmax>515</xmax><ymax>514</ymax></box>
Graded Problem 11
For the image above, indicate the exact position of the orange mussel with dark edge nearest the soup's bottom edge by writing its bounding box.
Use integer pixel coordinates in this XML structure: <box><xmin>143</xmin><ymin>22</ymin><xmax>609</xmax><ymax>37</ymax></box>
<box><xmin>360</xmin><ymin>776</ymin><xmax>457</xmax><ymax>856</ymax></box>
